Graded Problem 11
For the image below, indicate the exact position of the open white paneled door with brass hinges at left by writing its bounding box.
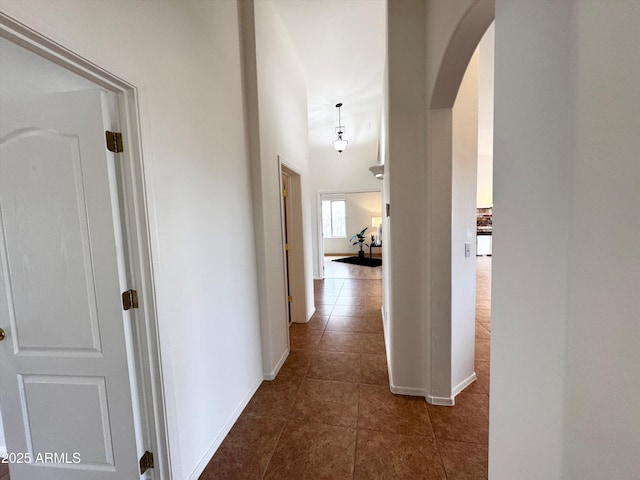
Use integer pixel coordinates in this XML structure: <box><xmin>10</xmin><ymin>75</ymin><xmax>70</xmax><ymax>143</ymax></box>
<box><xmin>0</xmin><ymin>90</ymin><xmax>140</xmax><ymax>480</ymax></box>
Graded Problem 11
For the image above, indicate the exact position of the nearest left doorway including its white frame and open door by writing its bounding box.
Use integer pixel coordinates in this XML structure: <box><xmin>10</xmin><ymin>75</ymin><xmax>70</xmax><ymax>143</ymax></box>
<box><xmin>0</xmin><ymin>14</ymin><xmax>169</xmax><ymax>480</ymax></box>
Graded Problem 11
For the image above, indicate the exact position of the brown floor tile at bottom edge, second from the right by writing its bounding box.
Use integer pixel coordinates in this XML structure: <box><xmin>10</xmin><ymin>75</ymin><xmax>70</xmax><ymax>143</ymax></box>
<box><xmin>354</xmin><ymin>429</ymin><xmax>447</xmax><ymax>480</ymax></box>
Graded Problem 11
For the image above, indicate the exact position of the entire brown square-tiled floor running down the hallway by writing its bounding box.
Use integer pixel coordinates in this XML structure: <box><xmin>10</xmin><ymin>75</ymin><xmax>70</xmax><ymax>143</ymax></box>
<box><xmin>200</xmin><ymin>257</ymin><xmax>491</xmax><ymax>480</ymax></box>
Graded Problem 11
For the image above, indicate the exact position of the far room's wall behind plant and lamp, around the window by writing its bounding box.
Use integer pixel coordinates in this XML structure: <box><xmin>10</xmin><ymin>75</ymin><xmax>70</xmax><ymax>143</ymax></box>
<box><xmin>324</xmin><ymin>192</ymin><xmax>382</xmax><ymax>255</ymax></box>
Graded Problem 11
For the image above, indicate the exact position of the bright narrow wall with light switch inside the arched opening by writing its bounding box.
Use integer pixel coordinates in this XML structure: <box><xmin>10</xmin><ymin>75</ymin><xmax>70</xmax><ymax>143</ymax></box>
<box><xmin>451</xmin><ymin>51</ymin><xmax>479</xmax><ymax>394</ymax></box>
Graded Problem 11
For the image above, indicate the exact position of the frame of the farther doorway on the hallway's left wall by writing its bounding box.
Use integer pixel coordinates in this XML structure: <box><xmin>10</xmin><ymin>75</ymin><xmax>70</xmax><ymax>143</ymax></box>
<box><xmin>278</xmin><ymin>156</ymin><xmax>307</xmax><ymax>323</ymax></box>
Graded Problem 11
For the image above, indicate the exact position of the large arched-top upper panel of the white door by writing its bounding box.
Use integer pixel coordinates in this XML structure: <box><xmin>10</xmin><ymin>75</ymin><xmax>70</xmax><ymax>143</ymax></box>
<box><xmin>0</xmin><ymin>129</ymin><xmax>101</xmax><ymax>355</ymax></box>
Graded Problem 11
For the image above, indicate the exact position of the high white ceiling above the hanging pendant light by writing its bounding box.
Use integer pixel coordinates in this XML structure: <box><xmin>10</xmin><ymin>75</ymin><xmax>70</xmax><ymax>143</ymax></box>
<box><xmin>273</xmin><ymin>0</ymin><xmax>386</xmax><ymax>147</ymax></box>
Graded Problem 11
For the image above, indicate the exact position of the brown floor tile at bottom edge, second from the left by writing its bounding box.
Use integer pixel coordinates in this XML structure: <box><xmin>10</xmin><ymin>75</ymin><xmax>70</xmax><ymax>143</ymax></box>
<box><xmin>265</xmin><ymin>421</ymin><xmax>356</xmax><ymax>480</ymax></box>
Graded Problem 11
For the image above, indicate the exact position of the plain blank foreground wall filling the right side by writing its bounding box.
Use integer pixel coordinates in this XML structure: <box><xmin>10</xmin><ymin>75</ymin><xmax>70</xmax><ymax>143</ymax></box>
<box><xmin>489</xmin><ymin>0</ymin><xmax>640</xmax><ymax>480</ymax></box>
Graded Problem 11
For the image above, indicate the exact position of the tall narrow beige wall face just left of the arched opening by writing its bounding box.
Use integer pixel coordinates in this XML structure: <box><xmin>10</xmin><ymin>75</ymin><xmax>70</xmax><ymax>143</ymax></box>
<box><xmin>383</xmin><ymin>0</ymin><xmax>428</xmax><ymax>395</ymax></box>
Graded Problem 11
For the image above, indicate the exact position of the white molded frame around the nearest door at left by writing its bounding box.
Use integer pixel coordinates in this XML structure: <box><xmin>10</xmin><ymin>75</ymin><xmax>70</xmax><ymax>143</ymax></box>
<box><xmin>0</xmin><ymin>12</ymin><xmax>171</xmax><ymax>480</ymax></box>
